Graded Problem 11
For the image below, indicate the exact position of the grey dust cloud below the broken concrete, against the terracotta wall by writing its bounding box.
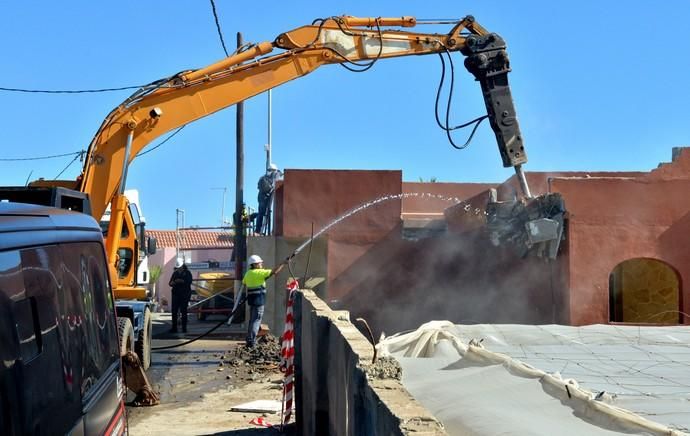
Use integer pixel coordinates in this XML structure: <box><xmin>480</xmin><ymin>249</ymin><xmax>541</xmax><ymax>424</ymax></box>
<box><xmin>336</xmin><ymin>223</ymin><xmax>557</xmax><ymax>335</ymax></box>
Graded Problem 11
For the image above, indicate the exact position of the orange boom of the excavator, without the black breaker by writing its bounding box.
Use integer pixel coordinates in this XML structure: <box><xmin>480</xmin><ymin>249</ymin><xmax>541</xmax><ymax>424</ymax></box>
<box><xmin>77</xmin><ymin>16</ymin><xmax>525</xmax><ymax>219</ymax></box>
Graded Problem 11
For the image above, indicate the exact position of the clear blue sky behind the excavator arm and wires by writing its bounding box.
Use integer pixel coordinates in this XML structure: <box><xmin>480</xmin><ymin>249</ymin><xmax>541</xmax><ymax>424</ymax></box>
<box><xmin>0</xmin><ymin>0</ymin><xmax>690</xmax><ymax>228</ymax></box>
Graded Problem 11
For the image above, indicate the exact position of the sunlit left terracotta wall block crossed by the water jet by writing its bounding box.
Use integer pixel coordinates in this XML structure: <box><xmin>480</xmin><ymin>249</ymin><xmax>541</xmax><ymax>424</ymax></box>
<box><xmin>276</xmin><ymin>170</ymin><xmax>402</xmax><ymax>301</ymax></box>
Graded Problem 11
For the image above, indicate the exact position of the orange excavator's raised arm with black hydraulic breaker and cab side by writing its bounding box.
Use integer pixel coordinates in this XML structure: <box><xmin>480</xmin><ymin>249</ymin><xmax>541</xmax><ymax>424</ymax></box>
<box><xmin>25</xmin><ymin>16</ymin><xmax>531</xmax><ymax>292</ymax></box>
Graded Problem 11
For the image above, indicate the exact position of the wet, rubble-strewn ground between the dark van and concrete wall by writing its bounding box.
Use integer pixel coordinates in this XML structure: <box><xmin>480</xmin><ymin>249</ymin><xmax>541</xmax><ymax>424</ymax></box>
<box><xmin>128</xmin><ymin>314</ymin><xmax>294</xmax><ymax>436</ymax></box>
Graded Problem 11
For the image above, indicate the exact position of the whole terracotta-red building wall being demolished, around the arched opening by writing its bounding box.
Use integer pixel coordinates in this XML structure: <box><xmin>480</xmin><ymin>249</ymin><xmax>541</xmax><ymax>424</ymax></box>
<box><xmin>276</xmin><ymin>150</ymin><xmax>690</xmax><ymax>332</ymax></box>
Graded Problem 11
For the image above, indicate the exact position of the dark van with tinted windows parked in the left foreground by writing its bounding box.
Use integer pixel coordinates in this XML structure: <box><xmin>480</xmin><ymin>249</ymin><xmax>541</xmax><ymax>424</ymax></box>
<box><xmin>0</xmin><ymin>202</ymin><xmax>127</xmax><ymax>435</ymax></box>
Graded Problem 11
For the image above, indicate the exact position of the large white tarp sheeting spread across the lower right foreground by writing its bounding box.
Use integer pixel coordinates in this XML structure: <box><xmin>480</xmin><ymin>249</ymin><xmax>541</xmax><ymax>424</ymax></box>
<box><xmin>379</xmin><ymin>321</ymin><xmax>690</xmax><ymax>435</ymax></box>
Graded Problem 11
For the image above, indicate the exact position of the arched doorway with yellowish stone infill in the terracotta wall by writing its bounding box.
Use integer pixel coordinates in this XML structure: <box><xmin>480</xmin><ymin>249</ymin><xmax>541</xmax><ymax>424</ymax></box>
<box><xmin>609</xmin><ymin>258</ymin><xmax>682</xmax><ymax>324</ymax></box>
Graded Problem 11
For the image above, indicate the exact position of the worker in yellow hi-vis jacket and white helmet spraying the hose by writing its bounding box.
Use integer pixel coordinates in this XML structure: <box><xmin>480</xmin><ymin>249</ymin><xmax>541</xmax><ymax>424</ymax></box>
<box><xmin>242</xmin><ymin>254</ymin><xmax>285</xmax><ymax>347</ymax></box>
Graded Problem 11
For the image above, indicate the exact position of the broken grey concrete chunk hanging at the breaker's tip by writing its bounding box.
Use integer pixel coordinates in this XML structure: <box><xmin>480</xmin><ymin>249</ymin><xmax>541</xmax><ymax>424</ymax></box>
<box><xmin>486</xmin><ymin>191</ymin><xmax>566</xmax><ymax>259</ymax></box>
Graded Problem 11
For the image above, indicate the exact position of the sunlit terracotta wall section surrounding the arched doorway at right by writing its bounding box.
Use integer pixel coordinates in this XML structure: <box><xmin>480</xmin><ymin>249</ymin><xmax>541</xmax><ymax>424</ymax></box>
<box><xmin>552</xmin><ymin>177</ymin><xmax>690</xmax><ymax>325</ymax></box>
